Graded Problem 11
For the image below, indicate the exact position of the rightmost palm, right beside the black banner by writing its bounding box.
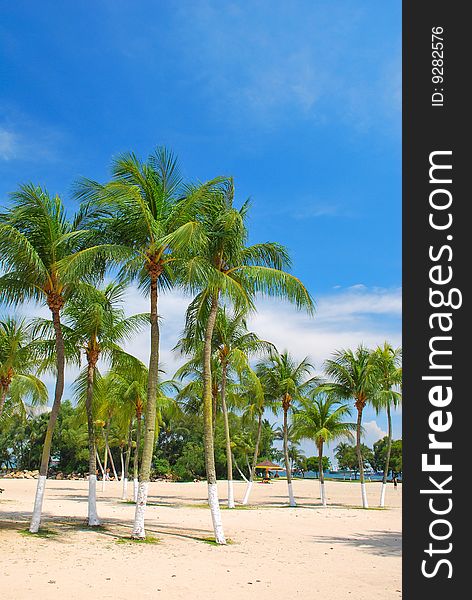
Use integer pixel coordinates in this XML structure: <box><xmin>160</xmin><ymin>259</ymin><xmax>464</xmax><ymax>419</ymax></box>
<box><xmin>373</xmin><ymin>342</ymin><xmax>402</xmax><ymax>507</ymax></box>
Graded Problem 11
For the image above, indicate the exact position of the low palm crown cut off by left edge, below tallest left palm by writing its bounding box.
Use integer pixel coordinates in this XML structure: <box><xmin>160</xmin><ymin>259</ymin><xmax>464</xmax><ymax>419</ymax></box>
<box><xmin>0</xmin><ymin>317</ymin><xmax>48</xmax><ymax>417</ymax></box>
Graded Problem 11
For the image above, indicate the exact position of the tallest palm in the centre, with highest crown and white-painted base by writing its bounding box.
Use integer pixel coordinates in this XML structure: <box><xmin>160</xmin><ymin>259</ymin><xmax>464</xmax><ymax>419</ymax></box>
<box><xmin>77</xmin><ymin>148</ymin><xmax>221</xmax><ymax>538</ymax></box>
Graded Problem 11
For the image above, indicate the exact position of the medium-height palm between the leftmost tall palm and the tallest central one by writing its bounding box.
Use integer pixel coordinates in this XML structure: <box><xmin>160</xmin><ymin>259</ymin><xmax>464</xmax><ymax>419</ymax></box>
<box><xmin>55</xmin><ymin>283</ymin><xmax>149</xmax><ymax>526</ymax></box>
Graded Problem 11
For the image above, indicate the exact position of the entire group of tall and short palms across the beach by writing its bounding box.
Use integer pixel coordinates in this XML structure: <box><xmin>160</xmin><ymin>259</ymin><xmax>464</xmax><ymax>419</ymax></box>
<box><xmin>0</xmin><ymin>148</ymin><xmax>401</xmax><ymax>544</ymax></box>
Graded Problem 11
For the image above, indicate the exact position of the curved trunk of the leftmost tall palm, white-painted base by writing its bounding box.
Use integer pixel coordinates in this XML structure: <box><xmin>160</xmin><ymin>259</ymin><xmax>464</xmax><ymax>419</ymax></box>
<box><xmin>29</xmin><ymin>308</ymin><xmax>65</xmax><ymax>533</ymax></box>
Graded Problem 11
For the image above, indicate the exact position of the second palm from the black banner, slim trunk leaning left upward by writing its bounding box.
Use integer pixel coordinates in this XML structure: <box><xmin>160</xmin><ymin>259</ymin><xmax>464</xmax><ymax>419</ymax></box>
<box><xmin>325</xmin><ymin>344</ymin><xmax>376</xmax><ymax>508</ymax></box>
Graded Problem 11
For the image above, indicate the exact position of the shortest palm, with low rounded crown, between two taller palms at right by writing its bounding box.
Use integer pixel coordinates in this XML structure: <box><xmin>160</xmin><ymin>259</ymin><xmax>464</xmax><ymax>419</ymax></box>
<box><xmin>293</xmin><ymin>388</ymin><xmax>356</xmax><ymax>506</ymax></box>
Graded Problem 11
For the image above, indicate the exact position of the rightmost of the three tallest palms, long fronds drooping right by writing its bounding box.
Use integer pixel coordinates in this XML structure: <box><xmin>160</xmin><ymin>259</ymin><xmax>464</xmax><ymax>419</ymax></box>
<box><xmin>187</xmin><ymin>180</ymin><xmax>313</xmax><ymax>544</ymax></box>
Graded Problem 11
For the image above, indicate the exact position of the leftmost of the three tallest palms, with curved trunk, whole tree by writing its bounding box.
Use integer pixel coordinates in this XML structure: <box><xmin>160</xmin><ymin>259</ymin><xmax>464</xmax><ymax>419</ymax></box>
<box><xmin>0</xmin><ymin>184</ymin><xmax>115</xmax><ymax>533</ymax></box>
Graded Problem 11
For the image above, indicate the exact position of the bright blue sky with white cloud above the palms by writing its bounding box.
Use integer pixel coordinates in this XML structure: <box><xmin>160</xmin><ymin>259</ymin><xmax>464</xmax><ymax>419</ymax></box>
<box><xmin>0</xmin><ymin>0</ymin><xmax>401</xmax><ymax>458</ymax></box>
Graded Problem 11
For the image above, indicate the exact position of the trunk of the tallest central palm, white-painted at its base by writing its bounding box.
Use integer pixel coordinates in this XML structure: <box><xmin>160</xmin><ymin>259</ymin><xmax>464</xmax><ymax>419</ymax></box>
<box><xmin>131</xmin><ymin>271</ymin><xmax>159</xmax><ymax>539</ymax></box>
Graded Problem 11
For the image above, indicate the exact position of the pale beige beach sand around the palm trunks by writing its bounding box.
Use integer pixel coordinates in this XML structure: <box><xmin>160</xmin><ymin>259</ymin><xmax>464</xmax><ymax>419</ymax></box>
<box><xmin>0</xmin><ymin>479</ymin><xmax>402</xmax><ymax>600</ymax></box>
